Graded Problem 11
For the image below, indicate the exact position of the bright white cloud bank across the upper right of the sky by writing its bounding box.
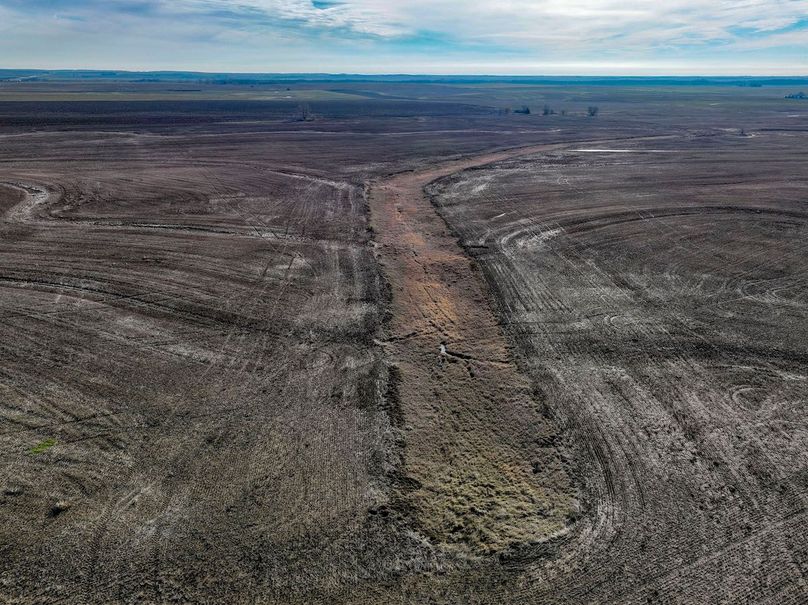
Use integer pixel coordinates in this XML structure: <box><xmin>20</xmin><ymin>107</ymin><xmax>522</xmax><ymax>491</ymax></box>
<box><xmin>181</xmin><ymin>0</ymin><xmax>808</xmax><ymax>47</ymax></box>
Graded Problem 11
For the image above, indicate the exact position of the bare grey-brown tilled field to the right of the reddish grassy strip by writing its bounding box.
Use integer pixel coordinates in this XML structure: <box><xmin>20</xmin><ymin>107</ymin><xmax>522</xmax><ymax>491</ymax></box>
<box><xmin>431</xmin><ymin>134</ymin><xmax>808</xmax><ymax>603</ymax></box>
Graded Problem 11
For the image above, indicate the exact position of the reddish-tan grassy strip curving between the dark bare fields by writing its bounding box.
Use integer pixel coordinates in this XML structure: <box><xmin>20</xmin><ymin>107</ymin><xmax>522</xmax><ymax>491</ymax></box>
<box><xmin>370</xmin><ymin>146</ymin><xmax>577</xmax><ymax>554</ymax></box>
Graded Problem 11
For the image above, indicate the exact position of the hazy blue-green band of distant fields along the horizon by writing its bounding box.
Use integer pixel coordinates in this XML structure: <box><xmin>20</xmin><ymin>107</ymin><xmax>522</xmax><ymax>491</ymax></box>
<box><xmin>0</xmin><ymin>79</ymin><xmax>808</xmax><ymax>115</ymax></box>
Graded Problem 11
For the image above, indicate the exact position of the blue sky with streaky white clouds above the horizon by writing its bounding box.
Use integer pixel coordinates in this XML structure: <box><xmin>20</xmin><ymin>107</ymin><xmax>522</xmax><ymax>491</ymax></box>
<box><xmin>0</xmin><ymin>0</ymin><xmax>808</xmax><ymax>75</ymax></box>
